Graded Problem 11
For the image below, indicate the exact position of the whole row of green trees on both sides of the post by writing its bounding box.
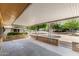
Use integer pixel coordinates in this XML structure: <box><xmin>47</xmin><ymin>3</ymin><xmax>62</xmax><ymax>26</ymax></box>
<box><xmin>27</xmin><ymin>19</ymin><xmax>79</xmax><ymax>32</ymax></box>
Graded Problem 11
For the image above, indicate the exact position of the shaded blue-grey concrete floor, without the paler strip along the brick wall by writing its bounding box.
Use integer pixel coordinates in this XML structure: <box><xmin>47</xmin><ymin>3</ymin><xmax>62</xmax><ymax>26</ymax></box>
<box><xmin>0</xmin><ymin>39</ymin><xmax>60</xmax><ymax>56</ymax></box>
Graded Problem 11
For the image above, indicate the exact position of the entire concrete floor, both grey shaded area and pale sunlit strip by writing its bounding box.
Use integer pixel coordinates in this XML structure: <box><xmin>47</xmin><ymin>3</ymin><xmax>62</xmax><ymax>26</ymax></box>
<box><xmin>0</xmin><ymin>37</ymin><xmax>79</xmax><ymax>56</ymax></box>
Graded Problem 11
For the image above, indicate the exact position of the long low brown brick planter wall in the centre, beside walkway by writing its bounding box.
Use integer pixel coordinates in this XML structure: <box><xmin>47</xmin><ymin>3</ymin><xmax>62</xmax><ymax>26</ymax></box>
<box><xmin>31</xmin><ymin>35</ymin><xmax>59</xmax><ymax>46</ymax></box>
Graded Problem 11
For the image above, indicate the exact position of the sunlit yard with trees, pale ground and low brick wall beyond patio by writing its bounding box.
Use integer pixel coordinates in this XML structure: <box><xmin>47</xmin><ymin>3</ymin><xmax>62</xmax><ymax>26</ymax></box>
<box><xmin>27</xmin><ymin>18</ymin><xmax>79</xmax><ymax>50</ymax></box>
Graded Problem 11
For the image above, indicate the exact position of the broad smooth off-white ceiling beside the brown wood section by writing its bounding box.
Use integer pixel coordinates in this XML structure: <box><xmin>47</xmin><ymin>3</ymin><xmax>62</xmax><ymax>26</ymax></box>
<box><xmin>15</xmin><ymin>3</ymin><xmax>79</xmax><ymax>25</ymax></box>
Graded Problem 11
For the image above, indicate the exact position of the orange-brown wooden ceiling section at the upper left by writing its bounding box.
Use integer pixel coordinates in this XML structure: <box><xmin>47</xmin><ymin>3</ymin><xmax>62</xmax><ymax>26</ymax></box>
<box><xmin>0</xmin><ymin>3</ymin><xmax>29</xmax><ymax>25</ymax></box>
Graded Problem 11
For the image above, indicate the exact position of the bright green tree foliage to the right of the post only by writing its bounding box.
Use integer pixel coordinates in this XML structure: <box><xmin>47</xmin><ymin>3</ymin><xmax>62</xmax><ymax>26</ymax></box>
<box><xmin>51</xmin><ymin>19</ymin><xmax>79</xmax><ymax>32</ymax></box>
